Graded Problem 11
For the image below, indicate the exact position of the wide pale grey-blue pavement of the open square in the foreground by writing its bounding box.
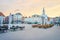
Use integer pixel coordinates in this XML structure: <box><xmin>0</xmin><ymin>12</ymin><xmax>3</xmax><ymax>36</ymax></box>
<box><xmin>0</xmin><ymin>26</ymin><xmax>60</xmax><ymax>40</ymax></box>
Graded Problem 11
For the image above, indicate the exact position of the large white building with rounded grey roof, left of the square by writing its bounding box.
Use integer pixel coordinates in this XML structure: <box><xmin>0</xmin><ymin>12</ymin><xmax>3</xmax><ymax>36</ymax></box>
<box><xmin>9</xmin><ymin>13</ymin><xmax>23</xmax><ymax>28</ymax></box>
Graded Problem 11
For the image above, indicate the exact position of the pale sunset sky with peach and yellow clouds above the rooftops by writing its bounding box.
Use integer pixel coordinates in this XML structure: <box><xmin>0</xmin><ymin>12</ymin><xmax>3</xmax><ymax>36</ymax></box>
<box><xmin>0</xmin><ymin>0</ymin><xmax>60</xmax><ymax>17</ymax></box>
